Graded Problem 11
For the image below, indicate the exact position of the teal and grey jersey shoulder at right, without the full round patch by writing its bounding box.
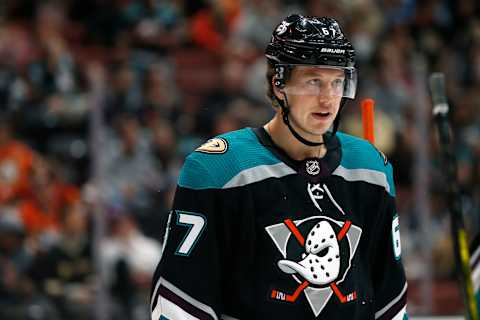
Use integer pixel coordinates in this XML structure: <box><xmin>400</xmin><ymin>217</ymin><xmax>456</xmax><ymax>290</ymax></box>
<box><xmin>337</xmin><ymin>132</ymin><xmax>395</xmax><ymax>197</ymax></box>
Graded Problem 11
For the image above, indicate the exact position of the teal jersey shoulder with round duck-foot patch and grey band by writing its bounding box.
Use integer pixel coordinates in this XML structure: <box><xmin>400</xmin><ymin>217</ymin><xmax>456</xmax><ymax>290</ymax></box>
<box><xmin>178</xmin><ymin>128</ymin><xmax>290</xmax><ymax>189</ymax></box>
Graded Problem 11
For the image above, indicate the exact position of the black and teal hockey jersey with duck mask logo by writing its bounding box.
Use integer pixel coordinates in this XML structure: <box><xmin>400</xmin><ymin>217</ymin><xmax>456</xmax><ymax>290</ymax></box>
<box><xmin>151</xmin><ymin>128</ymin><xmax>407</xmax><ymax>320</ymax></box>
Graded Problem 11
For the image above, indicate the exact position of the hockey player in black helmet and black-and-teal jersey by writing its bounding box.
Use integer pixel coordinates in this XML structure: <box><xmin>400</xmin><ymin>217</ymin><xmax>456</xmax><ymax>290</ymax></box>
<box><xmin>151</xmin><ymin>15</ymin><xmax>407</xmax><ymax>320</ymax></box>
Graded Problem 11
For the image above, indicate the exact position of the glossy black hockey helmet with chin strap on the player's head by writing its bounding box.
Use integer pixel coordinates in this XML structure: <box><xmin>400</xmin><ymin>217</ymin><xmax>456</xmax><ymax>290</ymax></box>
<box><xmin>265</xmin><ymin>14</ymin><xmax>357</xmax><ymax>146</ymax></box>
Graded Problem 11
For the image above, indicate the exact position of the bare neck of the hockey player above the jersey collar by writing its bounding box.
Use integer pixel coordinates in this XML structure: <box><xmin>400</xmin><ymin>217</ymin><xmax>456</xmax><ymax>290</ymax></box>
<box><xmin>264</xmin><ymin>114</ymin><xmax>327</xmax><ymax>160</ymax></box>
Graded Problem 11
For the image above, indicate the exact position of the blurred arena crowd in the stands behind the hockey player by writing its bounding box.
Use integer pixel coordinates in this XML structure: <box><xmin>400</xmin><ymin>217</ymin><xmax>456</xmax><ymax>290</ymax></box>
<box><xmin>0</xmin><ymin>0</ymin><xmax>480</xmax><ymax>320</ymax></box>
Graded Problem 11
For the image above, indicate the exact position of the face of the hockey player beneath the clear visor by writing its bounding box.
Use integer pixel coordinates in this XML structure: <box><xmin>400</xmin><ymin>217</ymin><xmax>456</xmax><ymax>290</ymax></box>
<box><xmin>284</xmin><ymin>66</ymin><xmax>345</xmax><ymax>136</ymax></box>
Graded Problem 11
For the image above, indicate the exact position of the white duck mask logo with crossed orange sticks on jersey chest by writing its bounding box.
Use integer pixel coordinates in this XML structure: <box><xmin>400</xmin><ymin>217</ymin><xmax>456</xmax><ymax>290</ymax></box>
<box><xmin>265</xmin><ymin>216</ymin><xmax>362</xmax><ymax>316</ymax></box>
